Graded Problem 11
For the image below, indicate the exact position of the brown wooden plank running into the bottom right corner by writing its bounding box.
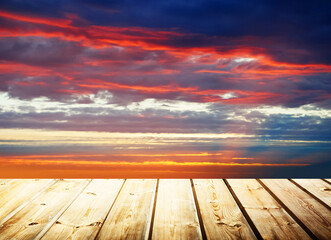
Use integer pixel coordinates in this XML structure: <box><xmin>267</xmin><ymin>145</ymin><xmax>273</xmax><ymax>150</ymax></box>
<box><xmin>261</xmin><ymin>179</ymin><xmax>331</xmax><ymax>239</ymax></box>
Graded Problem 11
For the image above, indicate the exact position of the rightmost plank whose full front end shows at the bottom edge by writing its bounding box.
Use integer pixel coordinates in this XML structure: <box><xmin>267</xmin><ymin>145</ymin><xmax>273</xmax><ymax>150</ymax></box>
<box><xmin>227</xmin><ymin>179</ymin><xmax>310</xmax><ymax>240</ymax></box>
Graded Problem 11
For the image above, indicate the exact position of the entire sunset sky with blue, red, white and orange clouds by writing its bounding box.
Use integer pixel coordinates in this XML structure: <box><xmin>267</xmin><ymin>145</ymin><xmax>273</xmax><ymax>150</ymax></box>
<box><xmin>0</xmin><ymin>0</ymin><xmax>331</xmax><ymax>178</ymax></box>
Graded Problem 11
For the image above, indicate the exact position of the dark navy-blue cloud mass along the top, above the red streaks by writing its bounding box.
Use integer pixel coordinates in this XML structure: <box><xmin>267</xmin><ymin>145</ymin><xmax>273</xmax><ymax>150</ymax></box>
<box><xmin>1</xmin><ymin>0</ymin><xmax>331</xmax><ymax>63</ymax></box>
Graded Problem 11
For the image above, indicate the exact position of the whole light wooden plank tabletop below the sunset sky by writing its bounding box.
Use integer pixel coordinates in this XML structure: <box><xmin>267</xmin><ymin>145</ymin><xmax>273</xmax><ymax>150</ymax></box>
<box><xmin>0</xmin><ymin>179</ymin><xmax>331</xmax><ymax>240</ymax></box>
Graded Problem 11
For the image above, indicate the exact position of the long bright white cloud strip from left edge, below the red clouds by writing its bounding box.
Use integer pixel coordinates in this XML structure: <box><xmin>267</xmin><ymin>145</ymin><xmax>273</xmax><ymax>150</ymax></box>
<box><xmin>0</xmin><ymin>91</ymin><xmax>211</xmax><ymax>115</ymax></box>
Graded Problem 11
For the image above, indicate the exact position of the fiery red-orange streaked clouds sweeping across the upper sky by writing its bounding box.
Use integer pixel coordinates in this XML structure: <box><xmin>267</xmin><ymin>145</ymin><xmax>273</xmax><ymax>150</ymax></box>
<box><xmin>0</xmin><ymin>11</ymin><xmax>331</xmax><ymax>104</ymax></box>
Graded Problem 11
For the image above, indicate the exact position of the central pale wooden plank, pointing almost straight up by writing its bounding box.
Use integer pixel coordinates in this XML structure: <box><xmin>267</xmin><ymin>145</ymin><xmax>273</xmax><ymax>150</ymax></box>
<box><xmin>152</xmin><ymin>179</ymin><xmax>202</xmax><ymax>240</ymax></box>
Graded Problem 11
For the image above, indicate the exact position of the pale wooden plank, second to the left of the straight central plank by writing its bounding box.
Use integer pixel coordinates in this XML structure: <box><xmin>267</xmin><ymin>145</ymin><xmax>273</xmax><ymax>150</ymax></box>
<box><xmin>42</xmin><ymin>179</ymin><xmax>124</xmax><ymax>240</ymax></box>
